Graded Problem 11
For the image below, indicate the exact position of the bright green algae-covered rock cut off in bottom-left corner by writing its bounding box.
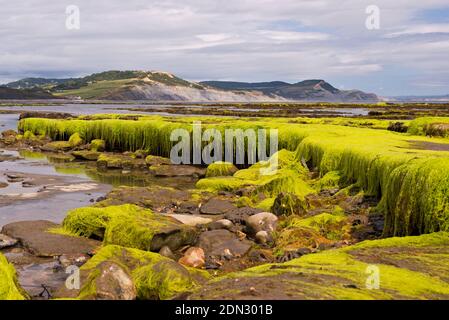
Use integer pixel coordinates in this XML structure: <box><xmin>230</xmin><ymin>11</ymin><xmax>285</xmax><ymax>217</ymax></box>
<box><xmin>0</xmin><ymin>253</ymin><xmax>26</xmax><ymax>300</ymax></box>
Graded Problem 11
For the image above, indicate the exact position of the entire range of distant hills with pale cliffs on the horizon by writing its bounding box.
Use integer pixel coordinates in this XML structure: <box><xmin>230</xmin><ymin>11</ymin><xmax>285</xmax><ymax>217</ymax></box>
<box><xmin>6</xmin><ymin>70</ymin><xmax>378</xmax><ymax>102</ymax></box>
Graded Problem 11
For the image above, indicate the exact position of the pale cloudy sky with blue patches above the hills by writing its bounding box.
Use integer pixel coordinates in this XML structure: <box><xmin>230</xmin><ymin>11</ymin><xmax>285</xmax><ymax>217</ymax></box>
<box><xmin>0</xmin><ymin>0</ymin><xmax>449</xmax><ymax>96</ymax></box>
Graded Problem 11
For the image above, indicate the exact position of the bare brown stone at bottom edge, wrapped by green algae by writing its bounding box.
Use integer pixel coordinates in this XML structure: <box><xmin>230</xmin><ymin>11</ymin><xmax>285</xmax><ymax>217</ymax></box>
<box><xmin>91</xmin><ymin>261</ymin><xmax>137</xmax><ymax>300</ymax></box>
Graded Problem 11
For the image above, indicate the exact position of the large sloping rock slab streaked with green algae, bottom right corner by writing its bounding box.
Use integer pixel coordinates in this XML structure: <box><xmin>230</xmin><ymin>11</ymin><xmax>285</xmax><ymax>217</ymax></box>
<box><xmin>189</xmin><ymin>232</ymin><xmax>449</xmax><ymax>300</ymax></box>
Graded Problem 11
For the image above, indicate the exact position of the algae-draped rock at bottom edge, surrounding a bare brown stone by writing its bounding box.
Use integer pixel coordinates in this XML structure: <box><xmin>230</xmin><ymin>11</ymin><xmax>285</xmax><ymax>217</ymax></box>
<box><xmin>78</xmin><ymin>245</ymin><xmax>209</xmax><ymax>300</ymax></box>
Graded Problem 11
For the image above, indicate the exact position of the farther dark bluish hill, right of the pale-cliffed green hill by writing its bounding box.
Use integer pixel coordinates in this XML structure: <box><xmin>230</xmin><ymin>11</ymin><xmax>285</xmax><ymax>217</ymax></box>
<box><xmin>201</xmin><ymin>80</ymin><xmax>379</xmax><ymax>102</ymax></box>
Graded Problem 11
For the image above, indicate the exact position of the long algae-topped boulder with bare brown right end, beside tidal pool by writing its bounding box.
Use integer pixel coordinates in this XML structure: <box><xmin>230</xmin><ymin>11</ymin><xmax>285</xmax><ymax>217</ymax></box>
<box><xmin>63</xmin><ymin>205</ymin><xmax>196</xmax><ymax>251</ymax></box>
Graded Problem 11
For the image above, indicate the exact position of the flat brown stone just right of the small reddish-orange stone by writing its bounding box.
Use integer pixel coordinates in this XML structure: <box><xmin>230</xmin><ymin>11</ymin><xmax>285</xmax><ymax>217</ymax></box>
<box><xmin>197</xmin><ymin>230</ymin><xmax>252</xmax><ymax>257</ymax></box>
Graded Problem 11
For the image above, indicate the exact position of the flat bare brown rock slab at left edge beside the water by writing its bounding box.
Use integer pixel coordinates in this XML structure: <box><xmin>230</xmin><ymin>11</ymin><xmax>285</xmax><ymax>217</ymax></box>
<box><xmin>2</xmin><ymin>220</ymin><xmax>101</xmax><ymax>257</ymax></box>
